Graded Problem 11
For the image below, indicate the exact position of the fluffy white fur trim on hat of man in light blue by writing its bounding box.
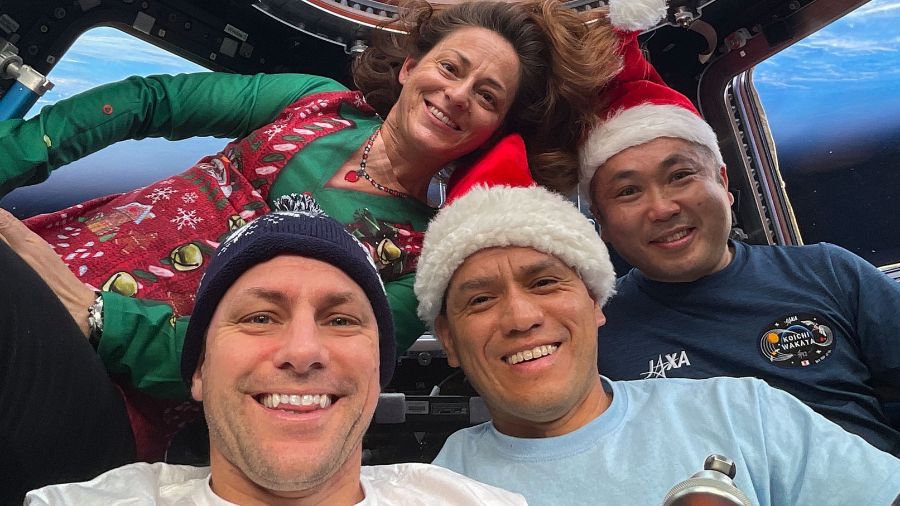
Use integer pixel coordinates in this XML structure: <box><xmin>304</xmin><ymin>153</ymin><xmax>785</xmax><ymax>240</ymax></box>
<box><xmin>415</xmin><ymin>186</ymin><xmax>615</xmax><ymax>329</ymax></box>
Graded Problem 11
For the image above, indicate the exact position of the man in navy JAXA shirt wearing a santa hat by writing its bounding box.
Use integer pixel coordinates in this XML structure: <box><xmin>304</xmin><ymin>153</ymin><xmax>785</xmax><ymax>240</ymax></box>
<box><xmin>579</xmin><ymin>9</ymin><xmax>900</xmax><ymax>456</ymax></box>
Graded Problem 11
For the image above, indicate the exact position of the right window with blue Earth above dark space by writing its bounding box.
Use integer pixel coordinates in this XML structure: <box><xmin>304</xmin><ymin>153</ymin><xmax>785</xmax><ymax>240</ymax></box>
<box><xmin>754</xmin><ymin>0</ymin><xmax>900</xmax><ymax>266</ymax></box>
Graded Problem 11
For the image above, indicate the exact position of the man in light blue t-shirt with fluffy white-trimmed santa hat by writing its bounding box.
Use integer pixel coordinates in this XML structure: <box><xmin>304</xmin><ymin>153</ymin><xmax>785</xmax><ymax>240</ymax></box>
<box><xmin>415</xmin><ymin>180</ymin><xmax>900</xmax><ymax>506</ymax></box>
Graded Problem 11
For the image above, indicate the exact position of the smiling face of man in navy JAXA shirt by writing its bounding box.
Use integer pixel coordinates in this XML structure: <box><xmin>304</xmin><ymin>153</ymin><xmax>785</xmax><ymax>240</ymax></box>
<box><xmin>591</xmin><ymin>137</ymin><xmax>734</xmax><ymax>282</ymax></box>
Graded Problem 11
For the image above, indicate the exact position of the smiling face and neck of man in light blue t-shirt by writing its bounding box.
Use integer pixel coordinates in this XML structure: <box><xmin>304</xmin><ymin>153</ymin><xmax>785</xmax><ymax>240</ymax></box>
<box><xmin>435</xmin><ymin>247</ymin><xmax>609</xmax><ymax>437</ymax></box>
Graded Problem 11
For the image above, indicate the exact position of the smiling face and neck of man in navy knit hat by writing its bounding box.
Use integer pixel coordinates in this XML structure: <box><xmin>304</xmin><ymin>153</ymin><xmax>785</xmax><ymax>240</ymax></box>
<box><xmin>191</xmin><ymin>256</ymin><xmax>380</xmax><ymax>503</ymax></box>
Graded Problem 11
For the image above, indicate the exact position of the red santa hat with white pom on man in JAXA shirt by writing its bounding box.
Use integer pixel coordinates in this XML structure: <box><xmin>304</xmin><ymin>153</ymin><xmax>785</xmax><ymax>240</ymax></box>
<box><xmin>578</xmin><ymin>0</ymin><xmax>724</xmax><ymax>201</ymax></box>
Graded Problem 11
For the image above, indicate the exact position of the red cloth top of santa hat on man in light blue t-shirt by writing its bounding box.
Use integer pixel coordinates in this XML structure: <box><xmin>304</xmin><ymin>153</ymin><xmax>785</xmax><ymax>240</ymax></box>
<box><xmin>444</xmin><ymin>134</ymin><xmax>536</xmax><ymax>205</ymax></box>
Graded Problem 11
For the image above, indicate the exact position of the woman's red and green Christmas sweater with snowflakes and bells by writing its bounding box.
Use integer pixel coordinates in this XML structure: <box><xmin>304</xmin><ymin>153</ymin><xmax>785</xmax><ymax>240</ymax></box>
<box><xmin>0</xmin><ymin>73</ymin><xmax>433</xmax><ymax>459</ymax></box>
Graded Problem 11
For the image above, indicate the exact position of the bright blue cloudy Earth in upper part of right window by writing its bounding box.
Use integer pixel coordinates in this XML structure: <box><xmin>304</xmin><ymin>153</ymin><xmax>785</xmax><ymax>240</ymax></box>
<box><xmin>754</xmin><ymin>0</ymin><xmax>900</xmax><ymax>170</ymax></box>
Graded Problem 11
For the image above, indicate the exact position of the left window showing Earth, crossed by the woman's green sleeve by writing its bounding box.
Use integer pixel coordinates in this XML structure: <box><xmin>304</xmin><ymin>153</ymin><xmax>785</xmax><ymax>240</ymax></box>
<box><xmin>0</xmin><ymin>27</ymin><xmax>227</xmax><ymax>218</ymax></box>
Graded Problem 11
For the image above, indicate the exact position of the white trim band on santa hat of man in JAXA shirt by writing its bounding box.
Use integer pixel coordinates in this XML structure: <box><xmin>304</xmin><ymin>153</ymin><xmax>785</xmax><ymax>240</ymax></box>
<box><xmin>578</xmin><ymin>104</ymin><xmax>725</xmax><ymax>202</ymax></box>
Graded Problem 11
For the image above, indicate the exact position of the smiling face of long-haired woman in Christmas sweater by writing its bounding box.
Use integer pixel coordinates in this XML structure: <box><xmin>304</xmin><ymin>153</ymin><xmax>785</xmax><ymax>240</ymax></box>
<box><xmin>384</xmin><ymin>27</ymin><xmax>520</xmax><ymax>163</ymax></box>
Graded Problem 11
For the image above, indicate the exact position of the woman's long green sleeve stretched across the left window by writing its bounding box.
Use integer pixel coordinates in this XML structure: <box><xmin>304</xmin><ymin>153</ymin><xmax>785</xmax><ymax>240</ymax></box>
<box><xmin>0</xmin><ymin>72</ymin><xmax>346</xmax><ymax>196</ymax></box>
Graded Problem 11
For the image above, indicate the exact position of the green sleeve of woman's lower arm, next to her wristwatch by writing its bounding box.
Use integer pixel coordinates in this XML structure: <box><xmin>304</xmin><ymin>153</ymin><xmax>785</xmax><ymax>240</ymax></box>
<box><xmin>97</xmin><ymin>292</ymin><xmax>190</xmax><ymax>399</ymax></box>
